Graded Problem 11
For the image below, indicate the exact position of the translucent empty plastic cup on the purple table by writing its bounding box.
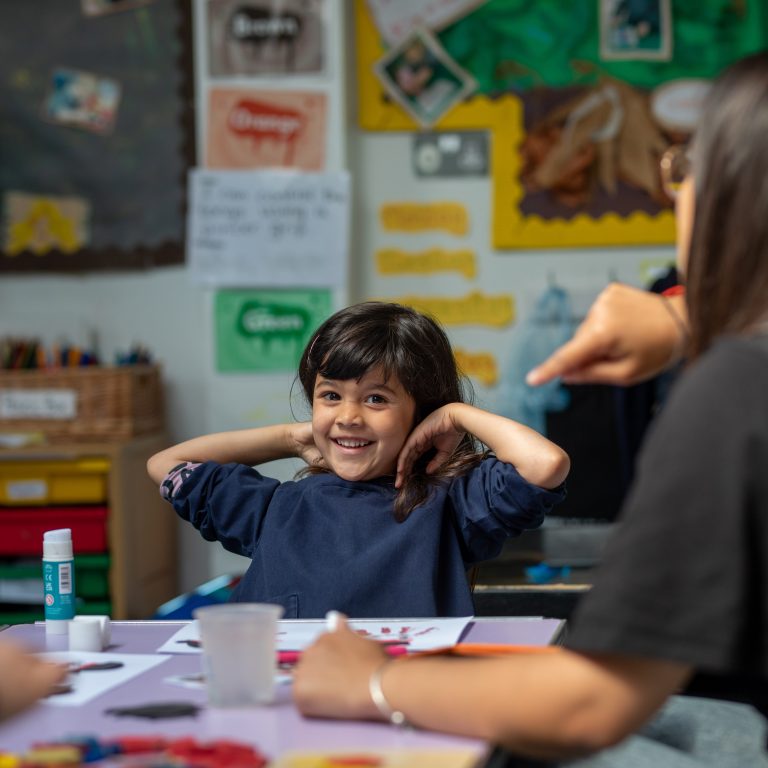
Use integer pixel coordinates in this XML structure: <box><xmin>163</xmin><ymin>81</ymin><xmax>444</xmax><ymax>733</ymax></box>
<box><xmin>192</xmin><ymin>603</ymin><xmax>283</xmax><ymax>707</ymax></box>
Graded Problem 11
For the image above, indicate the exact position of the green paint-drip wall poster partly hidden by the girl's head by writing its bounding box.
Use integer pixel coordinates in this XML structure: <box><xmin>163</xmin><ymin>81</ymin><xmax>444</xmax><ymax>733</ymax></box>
<box><xmin>214</xmin><ymin>289</ymin><xmax>332</xmax><ymax>373</ymax></box>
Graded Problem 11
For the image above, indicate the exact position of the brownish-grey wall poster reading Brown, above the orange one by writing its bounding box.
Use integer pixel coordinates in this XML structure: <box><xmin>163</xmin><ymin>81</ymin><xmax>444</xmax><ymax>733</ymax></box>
<box><xmin>207</xmin><ymin>0</ymin><xmax>325</xmax><ymax>78</ymax></box>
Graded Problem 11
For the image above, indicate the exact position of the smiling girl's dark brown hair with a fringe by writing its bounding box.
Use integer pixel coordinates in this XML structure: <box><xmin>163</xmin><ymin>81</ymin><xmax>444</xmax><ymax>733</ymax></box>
<box><xmin>298</xmin><ymin>301</ymin><xmax>481</xmax><ymax>522</ymax></box>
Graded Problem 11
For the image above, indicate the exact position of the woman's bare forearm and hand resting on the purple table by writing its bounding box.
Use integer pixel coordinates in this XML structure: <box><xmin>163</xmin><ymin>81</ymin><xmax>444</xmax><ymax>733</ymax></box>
<box><xmin>293</xmin><ymin>625</ymin><xmax>690</xmax><ymax>758</ymax></box>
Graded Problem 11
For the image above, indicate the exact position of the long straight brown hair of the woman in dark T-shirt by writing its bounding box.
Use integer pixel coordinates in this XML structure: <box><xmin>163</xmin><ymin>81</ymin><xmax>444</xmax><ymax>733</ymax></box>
<box><xmin>686</xmin><ymin>51</ymin><xmax>768</xmax><ymax>357</ymax></box>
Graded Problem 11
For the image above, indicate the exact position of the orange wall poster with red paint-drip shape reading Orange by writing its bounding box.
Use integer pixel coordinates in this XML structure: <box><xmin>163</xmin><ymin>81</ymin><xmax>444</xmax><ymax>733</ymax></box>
<box><xmin>205</xmin><ymin>88</ymin><xmax>327</xmax><ymax>171</ymax></box>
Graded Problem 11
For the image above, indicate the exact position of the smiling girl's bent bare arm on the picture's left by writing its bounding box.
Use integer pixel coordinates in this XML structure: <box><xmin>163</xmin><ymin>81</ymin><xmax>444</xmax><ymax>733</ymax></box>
<box><xmin>147</xmin><ymin>422</ymin><xmax>321</xmax><ymax>485</ymax></box>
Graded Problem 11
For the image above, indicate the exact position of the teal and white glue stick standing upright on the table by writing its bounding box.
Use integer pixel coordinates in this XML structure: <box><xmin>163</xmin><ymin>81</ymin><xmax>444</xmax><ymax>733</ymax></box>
<box><xmin>43</xmin><ymin>528</ymin><xmax>75</xmax><ymax>635</ymax></box>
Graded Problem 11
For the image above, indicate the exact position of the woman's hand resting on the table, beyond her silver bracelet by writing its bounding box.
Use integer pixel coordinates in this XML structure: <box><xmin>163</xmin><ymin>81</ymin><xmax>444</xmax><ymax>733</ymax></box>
<box><xmin>293</xmin><ymin>618</ymin><xmax>389</xmax><ymax>720</ymax></box>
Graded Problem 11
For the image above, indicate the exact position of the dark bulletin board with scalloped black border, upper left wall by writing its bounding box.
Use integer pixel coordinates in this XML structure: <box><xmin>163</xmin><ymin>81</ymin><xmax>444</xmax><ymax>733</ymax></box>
<box><xmin>0</xmin><ymin>0</ymin><xmax>194</xmax><ymax>272</ymax></box>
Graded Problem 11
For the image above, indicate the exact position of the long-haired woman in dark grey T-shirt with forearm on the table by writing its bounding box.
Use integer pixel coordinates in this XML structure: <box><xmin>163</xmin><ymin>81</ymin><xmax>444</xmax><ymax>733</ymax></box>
<box><xmin>294</xmin><ymin>52</ymin><xmax>768</xmax><ymax>768</ymax></box>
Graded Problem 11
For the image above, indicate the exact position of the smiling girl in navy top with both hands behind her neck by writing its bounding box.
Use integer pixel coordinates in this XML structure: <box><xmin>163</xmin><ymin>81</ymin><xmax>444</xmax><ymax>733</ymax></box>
<box><xmin>147</xmin><ymin>302</ymin><xmax>569</xmax><ymax>618</ymax></box>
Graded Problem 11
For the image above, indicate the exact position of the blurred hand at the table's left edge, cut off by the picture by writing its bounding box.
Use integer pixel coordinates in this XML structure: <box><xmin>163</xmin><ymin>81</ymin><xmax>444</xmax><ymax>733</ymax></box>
<box><xmin>0</xmin><ymin>641</ymin><xmax>67</xmax><ymax>720</ymax></box>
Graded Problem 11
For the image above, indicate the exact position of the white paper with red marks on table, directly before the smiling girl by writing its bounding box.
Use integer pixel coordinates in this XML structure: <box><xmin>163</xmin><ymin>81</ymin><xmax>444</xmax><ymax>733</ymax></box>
<box><xmin>157</xmin><ymin>616</ymin><xmax>473</xmax><ymax>653</ymax></box>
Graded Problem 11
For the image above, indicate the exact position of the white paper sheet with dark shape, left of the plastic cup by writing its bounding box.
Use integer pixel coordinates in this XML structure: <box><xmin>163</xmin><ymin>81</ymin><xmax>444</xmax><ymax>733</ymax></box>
<box><xmin>38</xmin><ymin>651</ymin><xmax>168</xmax><ymax>707</ymax></box>
